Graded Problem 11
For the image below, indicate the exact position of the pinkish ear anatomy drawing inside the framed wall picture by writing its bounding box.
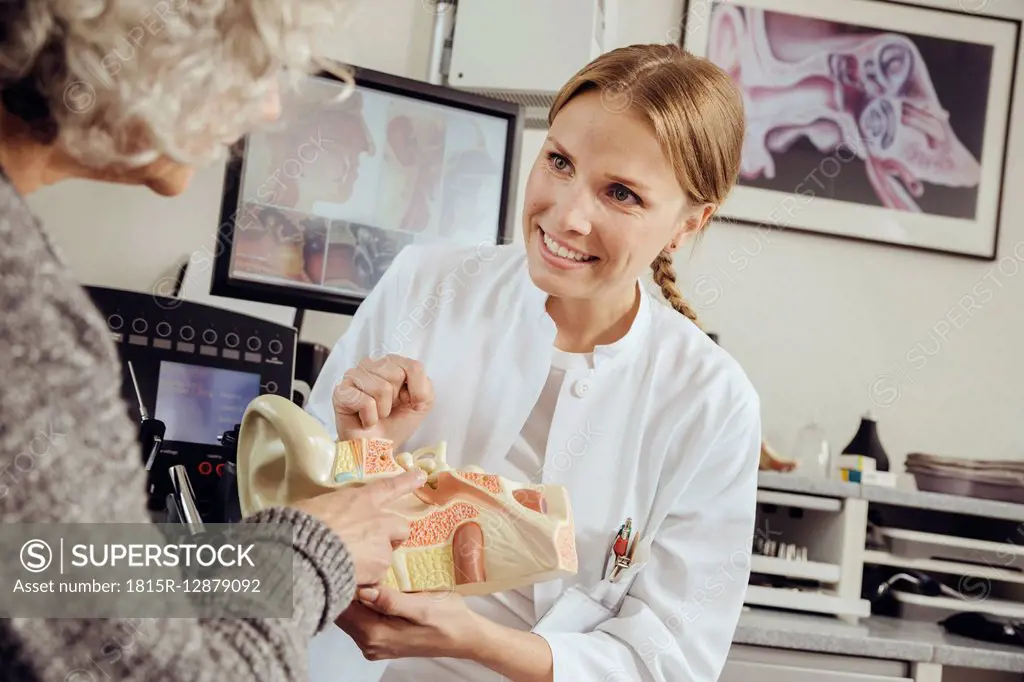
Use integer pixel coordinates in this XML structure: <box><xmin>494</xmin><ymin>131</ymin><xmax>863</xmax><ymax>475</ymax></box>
<box><xmin>708</xmin><ymin>3</ymin><xmax>981</xmax><ymax>214</ymax></box>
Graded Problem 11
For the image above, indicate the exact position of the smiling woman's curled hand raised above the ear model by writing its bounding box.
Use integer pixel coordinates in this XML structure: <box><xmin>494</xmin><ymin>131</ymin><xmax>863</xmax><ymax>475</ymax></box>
<box><xmin>333</xmin><ymin>355</ymin><xmax>434</xmax><ymax>447</ymax></box>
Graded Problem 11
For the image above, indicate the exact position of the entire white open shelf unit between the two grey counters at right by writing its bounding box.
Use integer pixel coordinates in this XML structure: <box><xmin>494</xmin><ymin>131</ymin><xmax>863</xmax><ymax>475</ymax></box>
<box><xmin>746</xmin><ymin>474</ymin><xmax>1024</xmax><ymax>623</ymax></box>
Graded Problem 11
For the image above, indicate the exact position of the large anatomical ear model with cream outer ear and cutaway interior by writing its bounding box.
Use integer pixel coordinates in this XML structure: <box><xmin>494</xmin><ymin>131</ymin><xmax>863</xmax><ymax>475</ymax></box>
<box><xmin>238</xmin><ymin>395</ymin><xmax>577</xmax><ymax>595</ymax></box>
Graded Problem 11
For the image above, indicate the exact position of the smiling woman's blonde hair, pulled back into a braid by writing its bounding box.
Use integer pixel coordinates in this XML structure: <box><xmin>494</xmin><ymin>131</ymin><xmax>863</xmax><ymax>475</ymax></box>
<box><xmin>548</xmin><ymin>44</ymin><xmax>745</xmax><ymax>324</ymax></box>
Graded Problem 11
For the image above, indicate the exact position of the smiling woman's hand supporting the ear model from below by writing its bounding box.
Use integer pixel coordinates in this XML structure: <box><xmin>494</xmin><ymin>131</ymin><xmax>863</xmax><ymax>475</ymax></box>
<box><xmin>335</xmin><ymin>586</ymin><xmax>481</xmax><ymax>660</ymax></box>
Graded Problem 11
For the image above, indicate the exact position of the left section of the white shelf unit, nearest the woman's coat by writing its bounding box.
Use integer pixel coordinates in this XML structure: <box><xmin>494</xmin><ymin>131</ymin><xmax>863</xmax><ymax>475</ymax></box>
<box><xmin>745</xmin><ymin>488</ymin><xmax>870</xmax><ymax>621</ymax></box>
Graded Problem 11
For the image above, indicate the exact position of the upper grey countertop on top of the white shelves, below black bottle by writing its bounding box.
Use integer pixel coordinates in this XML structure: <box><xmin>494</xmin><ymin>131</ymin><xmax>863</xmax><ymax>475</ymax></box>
<box><xmin>758</xmin><ymin>471</ymin><xmax>1024</xmax><ymax>521</ymax></box>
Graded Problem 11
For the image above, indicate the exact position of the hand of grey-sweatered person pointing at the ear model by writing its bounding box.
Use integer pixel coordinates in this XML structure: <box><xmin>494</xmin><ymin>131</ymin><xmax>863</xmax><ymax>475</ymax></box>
<box><xmin>293</xmin><ymin>469</ymin><xmax>426</xmax><ymax>585</ymax></box>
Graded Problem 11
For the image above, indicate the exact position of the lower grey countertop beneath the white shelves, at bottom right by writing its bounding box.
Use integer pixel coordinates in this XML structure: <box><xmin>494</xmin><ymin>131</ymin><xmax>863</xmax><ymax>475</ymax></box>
<box><xmin>732</xmin><ymin>608</ymin><xmax>1024</xmax><ymax>673</ymax></box>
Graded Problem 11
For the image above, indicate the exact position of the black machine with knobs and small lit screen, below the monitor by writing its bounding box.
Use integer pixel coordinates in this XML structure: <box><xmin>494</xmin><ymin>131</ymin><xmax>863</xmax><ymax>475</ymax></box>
<box><xmin>86</xmin><ymin>287</ymin><xmax>297</xmax><ymax>523</ymax></box>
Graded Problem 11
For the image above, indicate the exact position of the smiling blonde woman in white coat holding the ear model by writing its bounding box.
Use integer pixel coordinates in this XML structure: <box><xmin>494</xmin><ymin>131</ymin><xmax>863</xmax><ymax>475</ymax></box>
<box><xmin>308</xmin><ymin>45</ymin><xmax>761</xmax><ymax>682</ymax></box>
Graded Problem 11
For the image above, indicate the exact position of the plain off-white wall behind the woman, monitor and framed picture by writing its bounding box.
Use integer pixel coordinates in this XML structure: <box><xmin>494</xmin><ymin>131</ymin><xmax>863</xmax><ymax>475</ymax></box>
<box><xmin>32</xmin><ymin>0</ymin><xmax>1024</xmax><ymax>468</ymax></box>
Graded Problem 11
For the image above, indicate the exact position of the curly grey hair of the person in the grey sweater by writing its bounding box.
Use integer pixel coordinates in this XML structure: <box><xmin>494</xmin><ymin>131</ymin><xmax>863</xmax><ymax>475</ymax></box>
<box><xmin>0</xmin><ymin>0</ymin><xmax>352</xmax><ymax>168</ymax></box>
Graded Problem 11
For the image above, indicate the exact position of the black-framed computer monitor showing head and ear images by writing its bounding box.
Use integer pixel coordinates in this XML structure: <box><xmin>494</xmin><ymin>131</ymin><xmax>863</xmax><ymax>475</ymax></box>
<box><xmin>210</xmin><ymin>68</ymin><xmax>523</xmax><ymax>314</ymax></box>
